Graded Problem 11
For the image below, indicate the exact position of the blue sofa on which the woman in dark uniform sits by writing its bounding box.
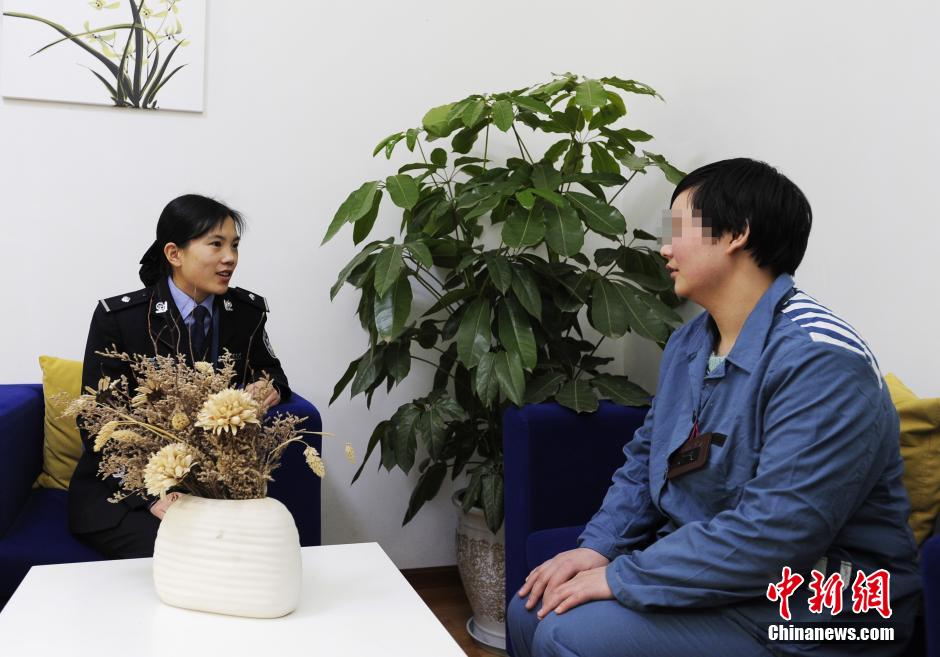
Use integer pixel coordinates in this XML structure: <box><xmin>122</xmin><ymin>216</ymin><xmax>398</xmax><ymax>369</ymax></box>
<box><xmin>0</xmin><ymin>384</ymin><xmax>321</xmax><ymax>608</ymax></box>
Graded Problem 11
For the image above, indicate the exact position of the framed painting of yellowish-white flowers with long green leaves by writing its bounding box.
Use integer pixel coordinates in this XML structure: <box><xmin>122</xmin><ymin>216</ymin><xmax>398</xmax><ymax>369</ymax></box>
<box><xmin>0</xmin><ymin>0</ymin><xmax>206</xmax><ymax>112</ymax></box>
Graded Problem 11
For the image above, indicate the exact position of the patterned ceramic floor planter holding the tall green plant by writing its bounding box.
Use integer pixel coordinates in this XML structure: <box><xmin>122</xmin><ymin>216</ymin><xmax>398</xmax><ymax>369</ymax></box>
<box><xmin>453</xmin><ymin>491</ymin><xmax>506</xmax><ymax>654</ymax></box>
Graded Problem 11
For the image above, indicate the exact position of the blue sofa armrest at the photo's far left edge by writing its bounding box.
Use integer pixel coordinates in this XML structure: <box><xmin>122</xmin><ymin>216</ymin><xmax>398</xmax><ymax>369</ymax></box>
<box><xmin>0</xmin><ymin>383</ymin><xmax>45</xmax><ymax>536</ymax></box>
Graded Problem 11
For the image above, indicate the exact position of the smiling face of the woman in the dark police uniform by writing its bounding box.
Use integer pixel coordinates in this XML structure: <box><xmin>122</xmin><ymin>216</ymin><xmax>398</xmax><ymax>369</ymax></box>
<box><xmin>164</xmin><ymin>217</ymin><xmax>240</xmax><ymax>303</ymax></box>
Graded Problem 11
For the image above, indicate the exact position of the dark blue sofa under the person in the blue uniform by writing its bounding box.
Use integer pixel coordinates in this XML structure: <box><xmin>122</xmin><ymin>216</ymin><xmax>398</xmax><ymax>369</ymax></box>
<box><xmin>503</xmin><ymin>402</ymin><xmax>940</xmax><ymax>657</ymax></box>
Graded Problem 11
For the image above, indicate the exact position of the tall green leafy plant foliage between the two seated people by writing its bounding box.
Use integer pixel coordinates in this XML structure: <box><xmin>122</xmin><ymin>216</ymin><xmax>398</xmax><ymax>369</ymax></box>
<box><xmin>323</xmin><ymin>74</ymin><xmax>683</xmax><ymax>648</ymax></box>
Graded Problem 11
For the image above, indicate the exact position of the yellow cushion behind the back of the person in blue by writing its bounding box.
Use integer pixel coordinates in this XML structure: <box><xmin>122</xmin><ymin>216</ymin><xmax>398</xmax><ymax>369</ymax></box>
<box><xmin>885</xmin><ymin>374</ymin><xmax>940</xmax><ymax>545</ymax></box>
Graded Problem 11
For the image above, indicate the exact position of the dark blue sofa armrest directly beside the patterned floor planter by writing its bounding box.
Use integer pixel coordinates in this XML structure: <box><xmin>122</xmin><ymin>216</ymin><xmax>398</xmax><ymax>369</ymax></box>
<box><xmin>503</xmin><ymin>401</ymin><xmax>648</xmax><ymax>600</ymax></box>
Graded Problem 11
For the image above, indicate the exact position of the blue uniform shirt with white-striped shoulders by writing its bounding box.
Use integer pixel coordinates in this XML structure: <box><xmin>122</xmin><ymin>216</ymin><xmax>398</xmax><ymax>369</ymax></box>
<box><xmin>579</xmin><ymin>275</ymin><xmax>920</xmax><ymax>640</ymax></box>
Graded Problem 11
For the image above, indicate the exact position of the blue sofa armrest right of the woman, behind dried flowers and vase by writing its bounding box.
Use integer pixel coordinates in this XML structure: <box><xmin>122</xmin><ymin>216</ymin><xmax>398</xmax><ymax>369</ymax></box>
<box><xmin>268</xmin><ymin>392</ymin><xmax>323</xmax><ymax>546</ymax></box>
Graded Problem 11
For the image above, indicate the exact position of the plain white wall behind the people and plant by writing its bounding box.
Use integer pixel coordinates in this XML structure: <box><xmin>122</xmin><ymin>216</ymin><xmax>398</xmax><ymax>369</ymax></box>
<box><xmin>0</xmin><ymin>0</ymin><xmax>940</xmax><ymax>568</ymax></box>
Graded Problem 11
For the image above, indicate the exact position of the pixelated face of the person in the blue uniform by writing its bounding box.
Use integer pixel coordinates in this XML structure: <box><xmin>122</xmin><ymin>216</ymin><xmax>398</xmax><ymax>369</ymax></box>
<box><xmin>660</xmin><ymin>189</ymin><xmax>730</xmax><ymax>303</ymax></box>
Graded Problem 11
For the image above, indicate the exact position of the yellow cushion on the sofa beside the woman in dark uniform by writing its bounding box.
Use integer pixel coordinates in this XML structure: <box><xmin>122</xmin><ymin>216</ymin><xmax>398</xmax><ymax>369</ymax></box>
<box><xmin>36</xmin><ymin>356</ymin><xmax>82</xmax><ymax>490</ymax></box>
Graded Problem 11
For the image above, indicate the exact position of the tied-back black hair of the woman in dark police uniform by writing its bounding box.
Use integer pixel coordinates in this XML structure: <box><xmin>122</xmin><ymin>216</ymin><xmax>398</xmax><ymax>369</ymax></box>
<box><xmin>140</xmin><ymin>194</ymin><xmax>245</xmax><ymax>286</ymax></box>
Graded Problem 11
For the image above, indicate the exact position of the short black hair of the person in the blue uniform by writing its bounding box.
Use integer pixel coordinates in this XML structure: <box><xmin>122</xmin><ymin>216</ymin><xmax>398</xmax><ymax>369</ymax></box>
<box><xmin>672</xmin><ymin>157</ymin><xmax>813</xmax><ymax>275</ymax></box>
